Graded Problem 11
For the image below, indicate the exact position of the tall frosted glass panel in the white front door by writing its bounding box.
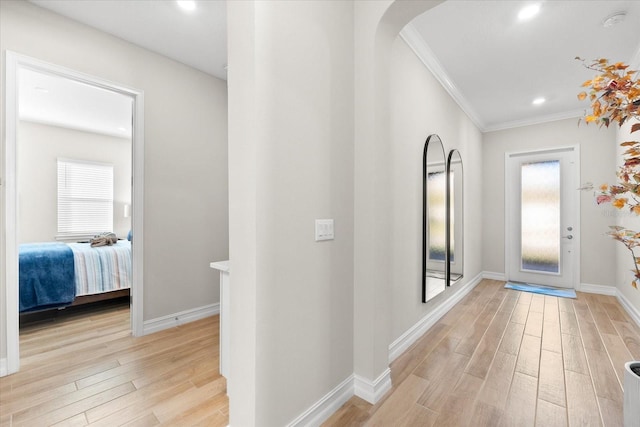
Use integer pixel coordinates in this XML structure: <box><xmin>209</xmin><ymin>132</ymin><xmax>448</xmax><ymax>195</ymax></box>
<box><xmin>520</xmin><ymin>160</ymin><xmax>560</xmax><ymax>273</ymax></box>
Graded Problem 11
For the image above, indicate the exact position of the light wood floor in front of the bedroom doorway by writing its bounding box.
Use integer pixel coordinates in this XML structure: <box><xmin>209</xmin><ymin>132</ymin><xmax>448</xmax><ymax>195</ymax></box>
<box><xmin>0</xmin><ymin>306</ymin><xmax>229</xmax><ymax>427</ymax></box>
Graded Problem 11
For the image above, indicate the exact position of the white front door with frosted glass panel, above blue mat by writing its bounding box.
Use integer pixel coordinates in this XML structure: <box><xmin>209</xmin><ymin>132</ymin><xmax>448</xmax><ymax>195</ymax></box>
<box><xmin>505</xmin><ymin>146</ymin><xmax>580</xmax><ymax>288</ymax></box>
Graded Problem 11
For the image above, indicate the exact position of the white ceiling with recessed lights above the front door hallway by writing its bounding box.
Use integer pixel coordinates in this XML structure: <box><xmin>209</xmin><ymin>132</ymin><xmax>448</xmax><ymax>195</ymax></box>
<box><xmin>403</xmin><ymin>0</ymin><xmax>640</xmax><ymax>131</ymax></box>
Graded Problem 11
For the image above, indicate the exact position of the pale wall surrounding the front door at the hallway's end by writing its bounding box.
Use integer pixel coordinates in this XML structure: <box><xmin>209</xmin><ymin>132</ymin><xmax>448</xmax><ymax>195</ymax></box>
<box><xmin>482</xmin><ymin>118</ymin><xmax>616</xmax><ymax>286</ymax></box>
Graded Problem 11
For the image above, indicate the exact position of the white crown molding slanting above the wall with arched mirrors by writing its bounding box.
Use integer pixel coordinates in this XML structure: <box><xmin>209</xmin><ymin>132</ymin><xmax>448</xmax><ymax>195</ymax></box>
<box><xmin>400</xmin><ymin>23</ymin><xmax>485</xmax><ymax>132</ymax></box>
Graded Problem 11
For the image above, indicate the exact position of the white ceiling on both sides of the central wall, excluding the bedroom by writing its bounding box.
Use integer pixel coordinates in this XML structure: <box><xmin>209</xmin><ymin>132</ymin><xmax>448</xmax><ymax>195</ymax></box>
<box><xmin>22</xmin><ymin>0</ymin><xmax>640</xmax><ymax>131</ymax></box>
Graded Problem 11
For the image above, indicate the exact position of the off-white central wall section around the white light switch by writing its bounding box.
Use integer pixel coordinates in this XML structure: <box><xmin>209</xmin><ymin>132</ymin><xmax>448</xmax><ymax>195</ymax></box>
<box><xmin>228</xmin><ymin>1</ymin><xmax>354</xmax><ymax>426</ymax></box>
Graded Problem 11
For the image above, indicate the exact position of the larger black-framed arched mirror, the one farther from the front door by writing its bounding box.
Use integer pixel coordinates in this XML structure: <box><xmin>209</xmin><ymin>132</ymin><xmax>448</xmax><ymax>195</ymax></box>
<box><xmin>422</xmin><ymin>134</ymin><xmax>447</xmax><ymax>302</ymax></box>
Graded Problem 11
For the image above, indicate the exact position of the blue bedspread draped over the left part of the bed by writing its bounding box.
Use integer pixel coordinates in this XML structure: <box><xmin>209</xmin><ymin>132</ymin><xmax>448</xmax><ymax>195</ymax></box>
<box><xmin>19</xmin><ymin>242</ymin><xmax>76</xmax><ymax>312</ymax></box>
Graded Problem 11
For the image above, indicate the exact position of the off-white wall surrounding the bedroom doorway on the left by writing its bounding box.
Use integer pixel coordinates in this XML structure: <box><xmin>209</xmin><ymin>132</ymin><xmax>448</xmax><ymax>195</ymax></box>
<box><xmin>0</xmin><ymin>1</ymin><xmax>228</xmax><ymax>366</ymax></box>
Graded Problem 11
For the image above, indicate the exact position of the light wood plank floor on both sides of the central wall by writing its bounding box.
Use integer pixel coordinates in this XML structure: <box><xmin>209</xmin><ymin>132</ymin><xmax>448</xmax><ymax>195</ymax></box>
<box><xmin>0</xmin><ymin>280</ymin><xmax>640</xmax><ymax>427</ymax></box>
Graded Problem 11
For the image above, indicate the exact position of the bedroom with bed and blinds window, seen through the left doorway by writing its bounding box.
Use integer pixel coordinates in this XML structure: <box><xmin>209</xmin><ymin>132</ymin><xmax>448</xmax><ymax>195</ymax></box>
<box><xmin>16</xmin><ymin>69</ymin><xmax>133</xmax><ymax>323</ymax></box>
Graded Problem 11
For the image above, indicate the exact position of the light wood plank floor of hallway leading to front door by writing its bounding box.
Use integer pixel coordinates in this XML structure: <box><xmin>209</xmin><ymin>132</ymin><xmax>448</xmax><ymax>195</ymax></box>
<box><xmin>324</xmin><ymin>280</ymin><xmax>640</xmax><ymax>427</ymax></box>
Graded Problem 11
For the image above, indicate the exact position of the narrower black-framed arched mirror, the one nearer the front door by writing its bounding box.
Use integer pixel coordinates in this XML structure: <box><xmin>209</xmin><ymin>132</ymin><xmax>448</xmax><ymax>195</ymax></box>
<box><xmin>446</xmin><ymin>150</ymin><xmax>464</xmax><ymax>286</ymax></box>
